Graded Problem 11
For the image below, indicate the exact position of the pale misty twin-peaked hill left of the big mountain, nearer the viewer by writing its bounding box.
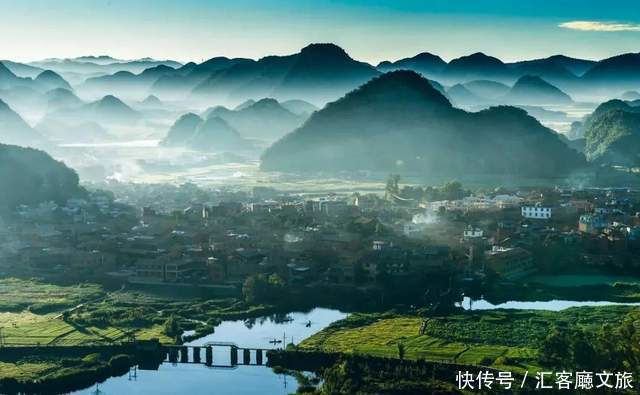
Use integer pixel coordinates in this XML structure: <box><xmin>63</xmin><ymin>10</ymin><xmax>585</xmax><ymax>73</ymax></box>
<box><xmin>161</xmin><ymin>113</ymin><xmax>251</xmax><ymax>152</ymax></box>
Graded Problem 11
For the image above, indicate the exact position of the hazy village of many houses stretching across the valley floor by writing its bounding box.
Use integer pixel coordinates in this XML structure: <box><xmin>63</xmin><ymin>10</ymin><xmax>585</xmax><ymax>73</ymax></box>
<box><xmin>0</xmin><ymin>180</ymin><xmax>640</xmax><ymax>295</ymax></box>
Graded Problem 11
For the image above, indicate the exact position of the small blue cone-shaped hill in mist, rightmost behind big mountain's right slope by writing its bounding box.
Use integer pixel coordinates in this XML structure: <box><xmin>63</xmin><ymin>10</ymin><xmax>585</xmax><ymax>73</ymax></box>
<box><xmin>504</xmin><ymin>75</ymin><xmax>573</xmax><ymax>105</ymax></box>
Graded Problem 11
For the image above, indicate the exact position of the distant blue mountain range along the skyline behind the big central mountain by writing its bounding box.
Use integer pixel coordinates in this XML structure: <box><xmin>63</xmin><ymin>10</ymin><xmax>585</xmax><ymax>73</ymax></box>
<box><xmin>5</xmin><ymin>44</ymin><xmax>640</xmax><ymax>105</ymax></box>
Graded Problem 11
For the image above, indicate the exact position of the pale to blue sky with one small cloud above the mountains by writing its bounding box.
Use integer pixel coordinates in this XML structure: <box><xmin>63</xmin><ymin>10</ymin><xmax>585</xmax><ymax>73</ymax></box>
<box><xmin>0</xmin><ymin>0</ymin><xmax>640</xmax><ymax>63</ymax></box>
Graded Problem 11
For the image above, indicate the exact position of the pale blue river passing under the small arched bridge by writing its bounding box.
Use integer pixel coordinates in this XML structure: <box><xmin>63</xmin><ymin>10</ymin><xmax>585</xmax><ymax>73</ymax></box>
<box><xmin>74</xmin><ymin>308</ymin><xmax>347</xmax><ymax>395</ymax></box>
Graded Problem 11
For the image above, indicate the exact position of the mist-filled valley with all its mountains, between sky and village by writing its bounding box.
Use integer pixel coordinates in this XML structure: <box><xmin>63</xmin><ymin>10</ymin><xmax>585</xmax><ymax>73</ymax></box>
<box><xmin>0</xmin><ymin>44</ymin><xmax>640</xmax><ymax>189</ymax></box>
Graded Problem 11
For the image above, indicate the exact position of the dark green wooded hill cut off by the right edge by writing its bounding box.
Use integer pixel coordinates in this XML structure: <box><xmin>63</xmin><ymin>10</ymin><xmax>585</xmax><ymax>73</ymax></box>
<box><xmin>584</xmin><ymin>110</ymin><xmax>640</xmax><ymax>166</ymax></box>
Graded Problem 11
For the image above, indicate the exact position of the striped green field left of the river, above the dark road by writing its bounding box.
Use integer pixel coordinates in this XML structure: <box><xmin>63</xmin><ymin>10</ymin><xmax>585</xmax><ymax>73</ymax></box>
<box><xmin>0</xmin><ymin>278</ymin><xmax>178</xmax><ymax>346</ymax></box>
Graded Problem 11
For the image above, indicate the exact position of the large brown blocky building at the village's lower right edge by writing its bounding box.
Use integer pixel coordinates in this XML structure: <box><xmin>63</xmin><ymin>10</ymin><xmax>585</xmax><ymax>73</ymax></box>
<box><xmin>484</xmin><ymin>246</ymin><xmax>535</xmax><ymax>280</ymax></box>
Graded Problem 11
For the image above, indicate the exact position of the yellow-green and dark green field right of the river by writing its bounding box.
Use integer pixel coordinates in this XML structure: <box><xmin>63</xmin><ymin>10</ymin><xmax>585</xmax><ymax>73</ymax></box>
<box><xmin>299</xmin><ymin>306</ymin><xmax>633</xmax><ymax>371</ymax></box>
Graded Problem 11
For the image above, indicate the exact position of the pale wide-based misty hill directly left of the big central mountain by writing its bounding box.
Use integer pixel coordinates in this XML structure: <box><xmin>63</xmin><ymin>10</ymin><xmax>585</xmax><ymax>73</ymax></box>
<box><xmin>203</xmin><ymin>98</ymin><xmax>307</xmax><ymax>141</ymax></box>
